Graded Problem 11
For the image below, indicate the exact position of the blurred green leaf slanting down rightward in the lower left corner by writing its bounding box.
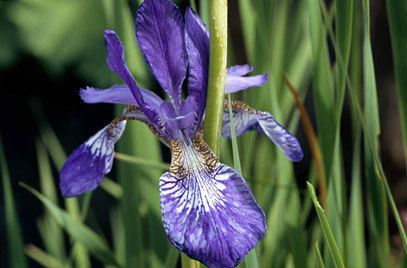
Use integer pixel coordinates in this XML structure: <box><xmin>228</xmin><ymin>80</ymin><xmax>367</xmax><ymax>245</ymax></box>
<box><xmin>20</xmin><ymin>182</ymin><xmax>120</xmax><ymax>266</ymax></box>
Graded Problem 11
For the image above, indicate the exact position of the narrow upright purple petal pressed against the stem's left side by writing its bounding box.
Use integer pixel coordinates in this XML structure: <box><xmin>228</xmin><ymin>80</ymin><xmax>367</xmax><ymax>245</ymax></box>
<box><xmin>185</xmin><ymin>8</ymin><xmax>209</xmax><ymax>133</ymax></box>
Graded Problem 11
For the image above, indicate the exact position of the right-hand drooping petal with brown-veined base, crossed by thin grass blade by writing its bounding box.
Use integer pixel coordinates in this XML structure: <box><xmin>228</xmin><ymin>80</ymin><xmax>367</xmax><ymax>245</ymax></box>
<box><xmin>221</xmin><ymin>102</ymin><xmax>303</xmax><ymax>162</ymax></box>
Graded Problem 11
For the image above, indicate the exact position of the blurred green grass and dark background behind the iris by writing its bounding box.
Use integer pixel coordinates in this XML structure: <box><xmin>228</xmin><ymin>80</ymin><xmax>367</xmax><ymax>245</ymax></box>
<box><xmin>0</xmin><ymin>0</ymin><xmax>407</xmax><ymax>268</ymax></box>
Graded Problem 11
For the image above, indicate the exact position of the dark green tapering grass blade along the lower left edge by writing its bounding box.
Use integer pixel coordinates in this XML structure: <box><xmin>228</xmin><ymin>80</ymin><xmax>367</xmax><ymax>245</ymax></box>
<box><xmin>0</xmin><ymin>136</ymin><xmax>27</xmax><ymax>268</ymax></box>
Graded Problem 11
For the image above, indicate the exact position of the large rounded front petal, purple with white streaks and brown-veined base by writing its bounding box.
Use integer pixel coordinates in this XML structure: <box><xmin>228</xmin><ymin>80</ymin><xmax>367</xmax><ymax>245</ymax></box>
<box><xmin>160</xmin><ymin>134</ymin><xmax>266</xmax><ymax>267</ymax></box>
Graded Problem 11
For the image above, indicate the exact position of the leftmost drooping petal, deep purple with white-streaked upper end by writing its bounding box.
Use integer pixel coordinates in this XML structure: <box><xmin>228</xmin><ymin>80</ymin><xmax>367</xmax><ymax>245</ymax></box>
<box><xmin>59</xmin><ymin>121</ymin><xmax>126</xmax><ymax>198</ymax></box>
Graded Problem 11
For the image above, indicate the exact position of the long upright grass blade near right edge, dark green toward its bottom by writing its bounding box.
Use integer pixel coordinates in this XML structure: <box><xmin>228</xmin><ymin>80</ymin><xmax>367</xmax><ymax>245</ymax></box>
<box><xmin>362</xmin><ymin>0</ymin><xmax>390</xmax><ymax>267</ymax></box>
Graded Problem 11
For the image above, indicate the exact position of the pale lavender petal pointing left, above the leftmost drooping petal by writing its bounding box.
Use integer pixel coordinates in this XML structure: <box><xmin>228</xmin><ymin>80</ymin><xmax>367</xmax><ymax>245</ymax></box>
<box><xmin>80</xmin><ymin>85</ymin><xmax>163</xmax><ymax>107</ymax></box>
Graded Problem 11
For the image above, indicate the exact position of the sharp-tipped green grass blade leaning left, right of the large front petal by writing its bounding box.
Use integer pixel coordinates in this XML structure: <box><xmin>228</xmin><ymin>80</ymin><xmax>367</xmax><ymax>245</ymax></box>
<box><xmin>307</xmin><ymin>182</ymin><xmax>345</xmax><ymax>268</ymax></box>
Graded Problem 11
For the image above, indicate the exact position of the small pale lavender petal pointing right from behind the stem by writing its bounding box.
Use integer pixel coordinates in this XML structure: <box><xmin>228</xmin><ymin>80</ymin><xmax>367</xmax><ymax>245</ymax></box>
<box><xmin>225</xmin><ymin>65</ymin><xmax>268</xmax><ymax>93</ymax></box>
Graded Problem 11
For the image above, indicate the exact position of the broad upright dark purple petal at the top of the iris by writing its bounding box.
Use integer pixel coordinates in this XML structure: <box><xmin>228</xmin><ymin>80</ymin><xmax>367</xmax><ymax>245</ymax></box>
<box><xmin>136</xmin><ymin>0</ymin><xmax>187</xmax><ymax>103</ymax></box>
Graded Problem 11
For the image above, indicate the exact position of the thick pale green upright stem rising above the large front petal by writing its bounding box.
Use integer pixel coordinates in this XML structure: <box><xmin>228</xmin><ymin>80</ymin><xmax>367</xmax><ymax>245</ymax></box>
<box><xmin>204</xmin><ymin>0</ymin><xmax>228</xmax><ymax>154</ymax></box>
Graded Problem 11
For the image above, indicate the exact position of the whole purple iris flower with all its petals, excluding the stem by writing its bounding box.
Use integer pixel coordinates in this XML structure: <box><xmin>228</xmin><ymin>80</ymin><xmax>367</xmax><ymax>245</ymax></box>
<box><xmin>60</xmin><ymin>0</ymin><xmax>302</xmax><ymax>267</ymax></box>
